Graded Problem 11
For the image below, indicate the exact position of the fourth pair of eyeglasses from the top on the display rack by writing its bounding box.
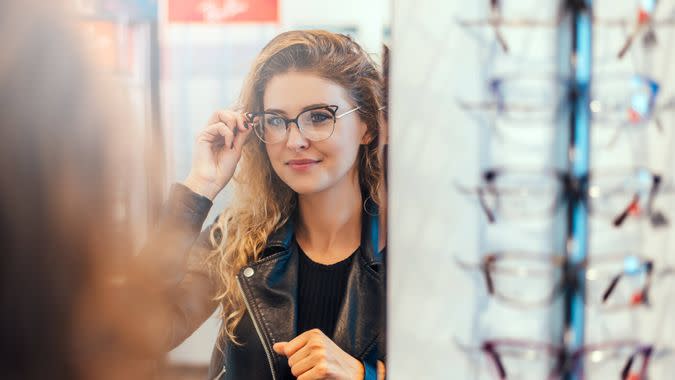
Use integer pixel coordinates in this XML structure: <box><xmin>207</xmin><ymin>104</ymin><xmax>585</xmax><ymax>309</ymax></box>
<box><xmin>455</xmin><ymin>252</ymin><xmax>674</xmax><ymax>311</ymax></box>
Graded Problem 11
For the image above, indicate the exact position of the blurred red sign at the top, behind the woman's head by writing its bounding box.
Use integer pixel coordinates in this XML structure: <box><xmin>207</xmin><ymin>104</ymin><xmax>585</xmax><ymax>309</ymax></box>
<box><xmin>167</xmin><ymin>0</ymin><xmax>279</xmax><ymax>23</ymax></box>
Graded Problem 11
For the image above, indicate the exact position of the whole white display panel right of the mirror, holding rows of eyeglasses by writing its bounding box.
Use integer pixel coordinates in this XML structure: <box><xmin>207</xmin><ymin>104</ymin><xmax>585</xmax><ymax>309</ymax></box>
<box><xmin>387</xmin><ymin>0</ymin><xmax>675</xmax><ymax>380</ymax></box>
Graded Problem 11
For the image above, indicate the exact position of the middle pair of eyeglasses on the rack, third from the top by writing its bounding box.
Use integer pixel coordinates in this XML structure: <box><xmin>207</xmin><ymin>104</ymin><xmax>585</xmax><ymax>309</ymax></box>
<box><xmin>455</xmin><ymin>168</ymin><xmax>670</xmax><ymax>227</ymax></box>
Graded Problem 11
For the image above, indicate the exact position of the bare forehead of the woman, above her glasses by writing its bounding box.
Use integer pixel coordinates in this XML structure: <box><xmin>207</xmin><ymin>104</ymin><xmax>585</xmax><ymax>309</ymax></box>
<box><xmin>263</xmin><ymin>71</ymin><xmax>350</xmax><ymax>114</ymax></box>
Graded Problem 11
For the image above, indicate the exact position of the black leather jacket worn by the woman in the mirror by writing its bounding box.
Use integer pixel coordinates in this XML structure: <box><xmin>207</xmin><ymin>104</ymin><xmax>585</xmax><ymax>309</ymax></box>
<box><xmin>140</xmin><ymin>185</ymin><xmax>386</xmax><ymax>380</ymax></box>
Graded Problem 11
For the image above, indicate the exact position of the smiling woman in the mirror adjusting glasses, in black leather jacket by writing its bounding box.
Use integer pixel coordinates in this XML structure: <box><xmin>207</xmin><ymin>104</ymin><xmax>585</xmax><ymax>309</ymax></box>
<box><xmin>139</xmin><ymin>31</ymin><xmax>385</xmax><ymax>380</ymax></box>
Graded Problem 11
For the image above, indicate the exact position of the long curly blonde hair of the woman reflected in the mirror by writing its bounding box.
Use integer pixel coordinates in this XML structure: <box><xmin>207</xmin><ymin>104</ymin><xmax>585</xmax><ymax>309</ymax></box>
<box><xmin>207</xmin><ymin>30</ymin><xmax>384</xmax><ymax>343</ymax></box>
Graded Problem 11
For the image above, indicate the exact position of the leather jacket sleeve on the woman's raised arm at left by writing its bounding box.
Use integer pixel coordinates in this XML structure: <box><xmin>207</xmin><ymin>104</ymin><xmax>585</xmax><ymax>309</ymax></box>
<box><xmin>135</xmin><ymin>184</ymin><xmax>222</xmax><ymax>351</ymax></box>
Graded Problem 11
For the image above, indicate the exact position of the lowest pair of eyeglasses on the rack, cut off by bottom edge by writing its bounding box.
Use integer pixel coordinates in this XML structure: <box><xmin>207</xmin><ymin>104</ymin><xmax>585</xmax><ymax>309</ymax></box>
<box><xmin>455</xmin><ymin>339</ymin><xmax>672</xmax><ymax>380</ymax></box>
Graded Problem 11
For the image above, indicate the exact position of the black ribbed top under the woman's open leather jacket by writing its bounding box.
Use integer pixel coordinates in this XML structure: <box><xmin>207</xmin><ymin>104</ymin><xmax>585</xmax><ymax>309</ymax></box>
<box><xmin>298</xmin><ymin>245</ymin><xmax>358</xmax><ymax>337</ymax></box>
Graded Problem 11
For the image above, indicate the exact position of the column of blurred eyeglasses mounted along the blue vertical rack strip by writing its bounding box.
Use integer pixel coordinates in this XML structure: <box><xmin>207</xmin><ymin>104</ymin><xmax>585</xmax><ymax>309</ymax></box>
<box><xmin>456</xmin><ymin>0</ymin><xmax>675</xmax><ymax>380</ymax></box>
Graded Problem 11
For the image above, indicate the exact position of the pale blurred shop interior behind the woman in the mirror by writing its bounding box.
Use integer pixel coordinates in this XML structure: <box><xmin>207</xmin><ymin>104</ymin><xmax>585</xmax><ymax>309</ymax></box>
<box><xmin>73</xmin><ymin>0</ymin><xmax>390</xmax><ymax>378</ymax></box>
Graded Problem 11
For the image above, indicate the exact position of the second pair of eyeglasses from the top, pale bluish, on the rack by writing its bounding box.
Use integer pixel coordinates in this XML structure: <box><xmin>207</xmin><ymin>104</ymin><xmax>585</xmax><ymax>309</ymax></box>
<box><xmin>458</xmin><ymin>74</ymin><xmax>675</xmax><ymax>148</ymax></box>
